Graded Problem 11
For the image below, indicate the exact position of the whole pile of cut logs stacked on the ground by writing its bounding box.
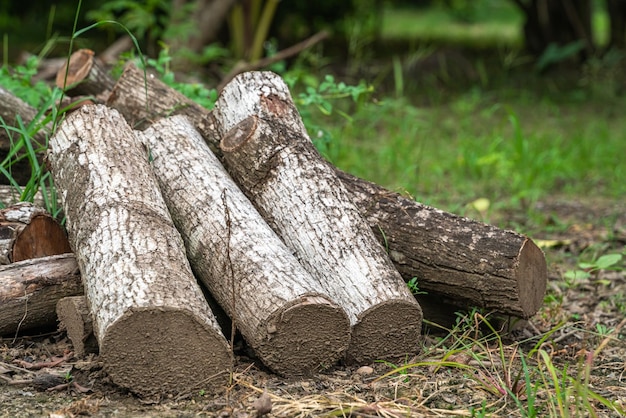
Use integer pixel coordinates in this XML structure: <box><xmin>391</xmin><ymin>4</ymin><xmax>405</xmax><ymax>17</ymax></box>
<box><xmin>0</xmin><ymin>51</ymin><xmax>547</xmax><ymax>395</ymax></box>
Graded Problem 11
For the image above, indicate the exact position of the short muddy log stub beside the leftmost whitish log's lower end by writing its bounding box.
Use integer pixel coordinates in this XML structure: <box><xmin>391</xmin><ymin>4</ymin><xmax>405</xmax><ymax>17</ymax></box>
<box><xmin>56</xmin><ymin>296</ymin><xmax>98</xmax><ymax>358</ymax></box>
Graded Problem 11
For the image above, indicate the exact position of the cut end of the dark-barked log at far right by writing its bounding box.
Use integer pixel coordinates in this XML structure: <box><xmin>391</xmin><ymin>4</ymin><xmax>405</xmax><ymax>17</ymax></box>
<box><xmin>516</xmin><ymin>239</ymin><xmax>548</xmax><ymax>319</ymax></box>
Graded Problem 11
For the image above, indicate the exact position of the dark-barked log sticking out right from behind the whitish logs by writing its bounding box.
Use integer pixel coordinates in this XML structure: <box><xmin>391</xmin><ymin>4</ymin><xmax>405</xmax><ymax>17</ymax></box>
<box><xmin>339</xmin><ymin>169</ymin><xmax>548</xmax><ymax>319</ymax></box>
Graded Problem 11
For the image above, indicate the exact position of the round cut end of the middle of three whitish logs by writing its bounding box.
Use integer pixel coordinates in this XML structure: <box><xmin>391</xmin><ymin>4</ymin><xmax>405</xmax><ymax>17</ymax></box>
<box><xmin>257</xmin><ymin>296</ymin><xmax>350</xmax><ymax>376</ymax></box>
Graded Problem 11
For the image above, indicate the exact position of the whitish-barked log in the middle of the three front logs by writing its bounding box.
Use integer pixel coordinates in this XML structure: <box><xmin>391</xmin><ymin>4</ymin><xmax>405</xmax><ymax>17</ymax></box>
<box><xmin>137</xmin><ymin>115</ymin><xmax>350</xmax><ymax>376</ymax></box>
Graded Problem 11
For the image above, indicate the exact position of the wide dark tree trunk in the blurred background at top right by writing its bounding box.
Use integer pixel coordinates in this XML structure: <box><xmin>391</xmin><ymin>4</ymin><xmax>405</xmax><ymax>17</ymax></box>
<box><xmin>514</xmin><ymin>0</ymin><xmax>595</xmax><ymax>59</ymax></box>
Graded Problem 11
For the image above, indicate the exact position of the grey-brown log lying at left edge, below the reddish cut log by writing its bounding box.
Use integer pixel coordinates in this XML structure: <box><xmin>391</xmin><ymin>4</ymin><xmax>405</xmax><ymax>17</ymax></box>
<box><xmin>0</xmin><ymin>254</ymin><xmax>83</xmax><ymax>335</ymax></box>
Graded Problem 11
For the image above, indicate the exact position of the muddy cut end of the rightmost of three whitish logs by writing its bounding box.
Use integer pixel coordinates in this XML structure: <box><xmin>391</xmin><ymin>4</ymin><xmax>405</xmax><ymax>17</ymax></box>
<box><xmin>346</xmin><ymin>300</ymin><xmax>422</xmax><ymax>364</ymax></box>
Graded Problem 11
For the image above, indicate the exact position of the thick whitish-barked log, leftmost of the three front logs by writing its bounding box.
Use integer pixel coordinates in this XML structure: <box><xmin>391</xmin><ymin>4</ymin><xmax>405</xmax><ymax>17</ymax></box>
<box><xmin>48</xmin><ymin>105</ymin><xmax>233</xmax><ymax>396</ymax></box>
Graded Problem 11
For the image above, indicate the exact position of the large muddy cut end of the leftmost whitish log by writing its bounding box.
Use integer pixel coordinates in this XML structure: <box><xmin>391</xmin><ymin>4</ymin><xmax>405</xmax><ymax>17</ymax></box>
<box><xmin>100</xmin><ymin>308</ymin><xmax>233</xmax><ymax>396</ymax></box>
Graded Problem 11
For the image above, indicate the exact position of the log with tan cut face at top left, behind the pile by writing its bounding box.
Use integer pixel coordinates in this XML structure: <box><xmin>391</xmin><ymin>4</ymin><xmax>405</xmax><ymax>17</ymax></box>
<box><xmin>56</xmin><ymin>49</ymin><xmax>115</xmax><ymax>97</ymax></box>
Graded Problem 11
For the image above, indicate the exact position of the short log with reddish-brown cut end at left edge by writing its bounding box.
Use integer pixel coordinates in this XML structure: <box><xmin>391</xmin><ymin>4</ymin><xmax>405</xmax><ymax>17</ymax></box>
<box><xmin>0</xmin><ymin>202</ymin><xmax>72</xmax><ymax>264</ymax></box>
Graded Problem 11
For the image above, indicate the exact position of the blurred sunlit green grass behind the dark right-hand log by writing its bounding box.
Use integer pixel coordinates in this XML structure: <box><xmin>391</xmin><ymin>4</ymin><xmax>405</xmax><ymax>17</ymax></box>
<box><xmin>310</xmin><ymin>89</ymin><xmax>626</xmax><ymax>219</ymax></box>
